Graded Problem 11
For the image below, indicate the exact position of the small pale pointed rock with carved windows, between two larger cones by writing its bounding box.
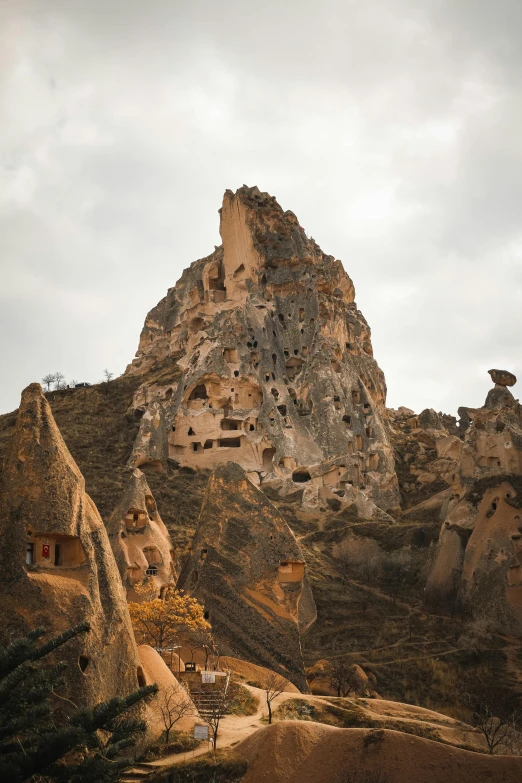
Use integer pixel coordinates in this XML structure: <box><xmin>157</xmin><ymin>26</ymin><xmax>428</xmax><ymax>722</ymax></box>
<box><xmin>107</xmin><ymin>468</ymin><xmax>177</xmax><ymax>601</ymax></box>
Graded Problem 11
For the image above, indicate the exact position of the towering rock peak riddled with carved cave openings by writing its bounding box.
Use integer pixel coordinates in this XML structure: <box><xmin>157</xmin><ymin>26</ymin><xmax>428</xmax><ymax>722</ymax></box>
<box><xmin>127</xmin><ymin>186</ymin><xmax>398</xmax><ymax>509</ymax></box>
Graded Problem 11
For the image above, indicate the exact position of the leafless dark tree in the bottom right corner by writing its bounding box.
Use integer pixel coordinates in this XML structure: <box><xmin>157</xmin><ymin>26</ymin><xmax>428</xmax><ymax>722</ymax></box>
<box><xmin>463</xmin><ymin>687</ymin><xmax>522</xmax><ymax>755</ymax></box>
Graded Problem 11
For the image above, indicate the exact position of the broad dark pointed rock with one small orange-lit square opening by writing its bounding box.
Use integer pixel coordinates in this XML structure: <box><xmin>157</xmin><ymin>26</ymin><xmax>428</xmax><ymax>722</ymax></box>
<box><xmin>178</xmin><ymin>462</ymin><xmax>315</xmax><ymax>689</ymax></box>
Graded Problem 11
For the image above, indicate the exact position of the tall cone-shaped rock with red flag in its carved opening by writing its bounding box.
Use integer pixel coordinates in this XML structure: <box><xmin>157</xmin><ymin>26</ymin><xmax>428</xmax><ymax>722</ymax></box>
<box><xmin>0</xmin><ymin>384</ymin><xmax>140</xmax><ymax>705</ymax></box>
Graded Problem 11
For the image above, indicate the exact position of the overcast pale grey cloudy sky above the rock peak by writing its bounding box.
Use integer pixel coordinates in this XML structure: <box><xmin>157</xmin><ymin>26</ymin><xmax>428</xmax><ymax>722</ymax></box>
<box><xmin>0</xmin><ymin>0</ymin><xmax>522</xmax><ymax>413</ymax></box>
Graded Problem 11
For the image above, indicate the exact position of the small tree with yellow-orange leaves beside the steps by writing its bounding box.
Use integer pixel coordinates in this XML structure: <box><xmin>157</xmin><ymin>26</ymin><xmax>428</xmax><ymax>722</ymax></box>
<box><xmin>129</xmin><ymin>585</ymin><xmax>210</xmax><ymax>649</ymax></box>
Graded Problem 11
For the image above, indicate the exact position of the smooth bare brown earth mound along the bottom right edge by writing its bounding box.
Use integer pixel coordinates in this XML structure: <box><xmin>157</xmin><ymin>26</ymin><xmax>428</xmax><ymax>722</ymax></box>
<box><xmin>240</xmin><ymin>721</ymin><xmax>522</xmax><ymax>783</ymax></box>
